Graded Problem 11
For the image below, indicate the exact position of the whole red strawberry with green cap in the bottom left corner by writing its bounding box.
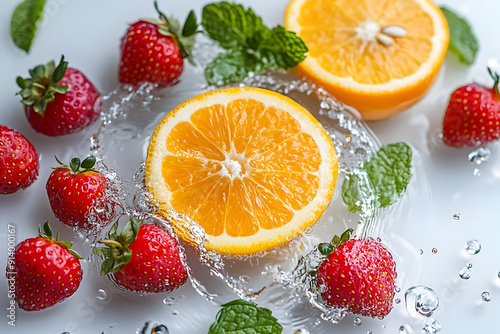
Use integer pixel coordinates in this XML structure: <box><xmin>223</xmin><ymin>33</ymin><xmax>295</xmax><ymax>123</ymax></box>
<box><xmin>7</xmin><ymin>221</ymin><xmax>82</xmax><ymax>311</ymax></box>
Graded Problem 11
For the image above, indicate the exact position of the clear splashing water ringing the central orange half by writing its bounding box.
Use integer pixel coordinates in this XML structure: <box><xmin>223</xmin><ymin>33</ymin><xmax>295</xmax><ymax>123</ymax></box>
<box><xmin>56</xmin><ymin>34</ymin><xmax>428</xmax><ymax>333</ymax></box>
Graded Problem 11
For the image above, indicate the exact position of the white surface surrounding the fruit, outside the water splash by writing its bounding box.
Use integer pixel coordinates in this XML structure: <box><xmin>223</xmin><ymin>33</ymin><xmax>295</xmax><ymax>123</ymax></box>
<box><xmin>0</xmin><ymin>0</ymin><xmax>500</xmax><ymax>334</ymax></box>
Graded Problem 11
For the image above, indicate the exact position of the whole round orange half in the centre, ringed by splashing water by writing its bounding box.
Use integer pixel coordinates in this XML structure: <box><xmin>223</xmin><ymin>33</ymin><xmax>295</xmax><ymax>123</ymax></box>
<box><xmin>145</xmin><ymin>87</ymin><xmax>338</xmax><ymax>256</ymax></box>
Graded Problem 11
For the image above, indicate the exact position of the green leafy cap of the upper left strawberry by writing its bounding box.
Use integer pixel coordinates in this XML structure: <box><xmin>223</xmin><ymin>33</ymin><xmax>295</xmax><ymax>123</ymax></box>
<box><xmin>16</xmin><ymin>55</ymin><xmax>68</xmax><ymax>116</ymax></box>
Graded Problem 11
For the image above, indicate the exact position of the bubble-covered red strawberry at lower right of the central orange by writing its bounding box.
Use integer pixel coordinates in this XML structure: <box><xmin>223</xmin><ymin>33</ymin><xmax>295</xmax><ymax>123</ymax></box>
<box><xmin>316</xmin><ymin>230</ymin><xmax>396</xmax><ymax>318</ymax></box>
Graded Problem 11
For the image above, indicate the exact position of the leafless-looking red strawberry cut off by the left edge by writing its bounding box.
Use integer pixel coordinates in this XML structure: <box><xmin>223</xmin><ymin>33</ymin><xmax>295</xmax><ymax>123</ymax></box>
<box><xmin>0</xmin><ymin>125</ymin><xmax>39</xmax><ymax>194</ymax></box>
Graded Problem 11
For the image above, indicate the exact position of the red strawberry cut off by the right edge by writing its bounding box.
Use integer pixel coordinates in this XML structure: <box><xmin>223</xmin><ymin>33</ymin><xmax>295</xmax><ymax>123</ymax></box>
<box><xmin>443</xmin><ymin>68</ymin><xmax>500</xmax><ymax>147</ymax></box>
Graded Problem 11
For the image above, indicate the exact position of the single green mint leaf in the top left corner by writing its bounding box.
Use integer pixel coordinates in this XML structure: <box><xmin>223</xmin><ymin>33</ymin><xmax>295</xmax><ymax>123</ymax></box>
<box><xmin>10</xmin><ymin>0</ymin><xmax>45</xmax><ymax>52</ymax></box>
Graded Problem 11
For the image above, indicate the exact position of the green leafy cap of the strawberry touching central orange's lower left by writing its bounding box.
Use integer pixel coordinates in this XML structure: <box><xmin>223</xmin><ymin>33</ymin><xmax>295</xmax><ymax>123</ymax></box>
<box><xmin>92</xmin><ymin>218</ymin><xmax>142</xmax><ymax>275</ymax></box>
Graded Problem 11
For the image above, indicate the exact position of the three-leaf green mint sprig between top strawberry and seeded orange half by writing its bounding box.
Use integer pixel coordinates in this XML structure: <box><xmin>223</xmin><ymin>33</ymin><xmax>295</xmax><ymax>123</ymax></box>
<box><xmin>201</xmin><ymin>2</ymin><xmax>308</xmax><ymax>85</ymax></box>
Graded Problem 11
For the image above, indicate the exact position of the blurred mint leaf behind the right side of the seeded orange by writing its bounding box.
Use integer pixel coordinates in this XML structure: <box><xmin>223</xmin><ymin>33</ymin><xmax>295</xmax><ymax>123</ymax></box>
<box><xmin>441</xmin><ymin>7</ymin><xmax>479</xmax><ymax>65</ymax></box>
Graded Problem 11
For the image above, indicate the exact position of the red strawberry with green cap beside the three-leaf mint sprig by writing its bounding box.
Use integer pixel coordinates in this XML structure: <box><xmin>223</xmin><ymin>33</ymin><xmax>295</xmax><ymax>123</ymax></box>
<box><xmin>119</xmin><ymin>1</ymin><xmax>198</xmax><ymax>87</ymax></box>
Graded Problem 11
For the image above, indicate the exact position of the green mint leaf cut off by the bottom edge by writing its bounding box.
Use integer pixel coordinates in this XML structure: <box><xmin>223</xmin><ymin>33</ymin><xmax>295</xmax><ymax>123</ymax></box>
<box><xmin>208</xmin><ymin>300</ymin><xmax>283</xmax><ymax>334</ymax></box>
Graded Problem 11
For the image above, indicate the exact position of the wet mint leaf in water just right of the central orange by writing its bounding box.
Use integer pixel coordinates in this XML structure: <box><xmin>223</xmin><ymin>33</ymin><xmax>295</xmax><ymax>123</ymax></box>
<box><xmin>342</xmin><ymin>142</ymin><xmax>413</xmax><ymax>212</ymax></box>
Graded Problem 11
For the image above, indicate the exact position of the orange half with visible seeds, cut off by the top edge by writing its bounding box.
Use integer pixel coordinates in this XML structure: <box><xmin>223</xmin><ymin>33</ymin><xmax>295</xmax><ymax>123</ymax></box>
<box><xmin>285</xmin><ymin>0</ymin><xmax>449</xmax><ymax>121</ymax></box>
